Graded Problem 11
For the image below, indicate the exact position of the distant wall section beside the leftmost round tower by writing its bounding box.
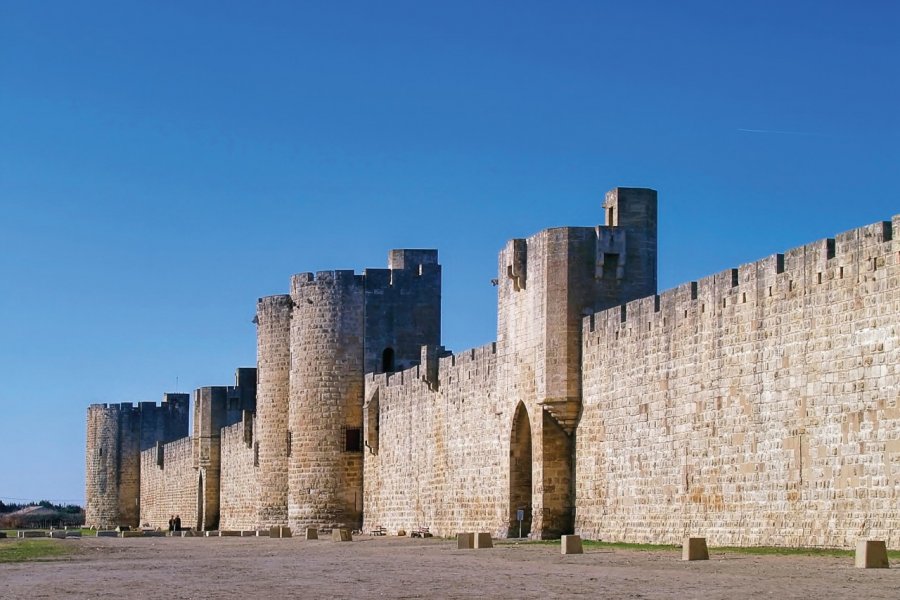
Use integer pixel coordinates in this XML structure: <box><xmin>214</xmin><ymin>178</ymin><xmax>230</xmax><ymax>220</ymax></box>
<box><xmin>140</xmin><ymin>437</ymin><xmax>199</xmax><ymax>530</ymax></box>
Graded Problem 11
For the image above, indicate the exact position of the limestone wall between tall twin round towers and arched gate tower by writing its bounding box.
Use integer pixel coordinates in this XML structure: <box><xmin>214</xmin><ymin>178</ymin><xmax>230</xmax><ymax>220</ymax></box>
<box><xmin>363</xmin><ymin>344</ymin><xmax>511</xmax><ymax>536</ymax></box>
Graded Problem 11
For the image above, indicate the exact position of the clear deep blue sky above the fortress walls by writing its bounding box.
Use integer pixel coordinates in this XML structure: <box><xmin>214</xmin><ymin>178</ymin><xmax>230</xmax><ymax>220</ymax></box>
<box><xmin>0</xmin><ymin>0</ymin><xmax>900</xmax><ymax>503</ymax></box>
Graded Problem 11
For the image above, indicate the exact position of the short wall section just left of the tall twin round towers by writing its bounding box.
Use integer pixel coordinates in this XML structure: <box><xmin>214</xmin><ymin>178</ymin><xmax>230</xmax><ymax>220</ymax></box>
<box><xmin>219</xmin><ymin>413</ymin><xmax>258</xmax><ymax>530</ymax></box>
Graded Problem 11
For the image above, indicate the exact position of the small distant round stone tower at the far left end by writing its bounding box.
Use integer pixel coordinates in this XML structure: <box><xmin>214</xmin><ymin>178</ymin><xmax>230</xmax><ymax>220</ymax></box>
<box><xmin>85</xmin><ymin>403</ymin><xmax>140</xmax><ymax>528</ymax></box>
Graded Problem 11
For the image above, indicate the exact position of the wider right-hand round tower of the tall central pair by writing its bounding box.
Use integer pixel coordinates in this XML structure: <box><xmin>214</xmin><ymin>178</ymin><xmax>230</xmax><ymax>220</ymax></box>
<box><xmin>288</xmin><ymin>271</ymin><xmax>365</xmax><ymax>530</ymax></box>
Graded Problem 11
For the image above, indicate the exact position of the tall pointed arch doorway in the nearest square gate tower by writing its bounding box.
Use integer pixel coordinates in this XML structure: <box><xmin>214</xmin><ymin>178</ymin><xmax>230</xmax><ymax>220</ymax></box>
<box><xmin>508</xmin><ymin>402</ymin><xmax>533</xmax><ymax>537</ymax></box>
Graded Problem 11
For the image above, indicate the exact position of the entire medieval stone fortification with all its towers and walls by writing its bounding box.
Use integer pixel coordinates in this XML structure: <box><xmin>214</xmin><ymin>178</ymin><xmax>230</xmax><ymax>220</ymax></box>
<box><xmin>86</xmin><ymin>188</ymin><xmax>900</xmax><ymax>547</ymax></box>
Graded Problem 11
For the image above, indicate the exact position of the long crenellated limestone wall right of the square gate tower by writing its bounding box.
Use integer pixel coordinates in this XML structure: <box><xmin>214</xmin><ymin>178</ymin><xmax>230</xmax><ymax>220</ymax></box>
<box><xmin>575</xmin><ymin>217</ymin><xmax>900</xmax><ymax>548</ymax></box>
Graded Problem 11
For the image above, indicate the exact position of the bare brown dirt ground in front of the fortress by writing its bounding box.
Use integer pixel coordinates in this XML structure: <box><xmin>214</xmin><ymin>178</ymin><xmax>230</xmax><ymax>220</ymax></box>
<box><xmin>0</xmin><ymin>536</ymin><xmax>900</xmax><ymax>600</ymax></box>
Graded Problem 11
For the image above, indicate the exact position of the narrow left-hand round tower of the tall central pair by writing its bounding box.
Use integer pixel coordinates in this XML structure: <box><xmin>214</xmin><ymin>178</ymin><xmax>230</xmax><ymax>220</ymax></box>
<box><xmin>254</xmin><ymin>294</ymin><xmax>293</xmax><ymax>527</ymax></box>
